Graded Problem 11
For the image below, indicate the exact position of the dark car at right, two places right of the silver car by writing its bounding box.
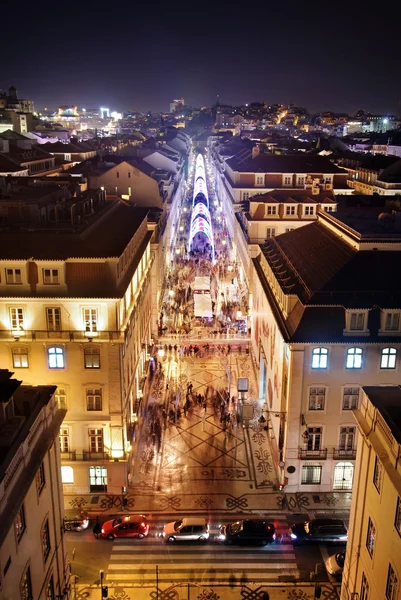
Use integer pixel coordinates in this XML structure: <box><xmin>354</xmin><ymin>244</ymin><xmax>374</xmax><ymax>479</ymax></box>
<box><xmin>290</xmin><ymin>519</ymin><xmax>348</xmax><ymax>544</ymax></box>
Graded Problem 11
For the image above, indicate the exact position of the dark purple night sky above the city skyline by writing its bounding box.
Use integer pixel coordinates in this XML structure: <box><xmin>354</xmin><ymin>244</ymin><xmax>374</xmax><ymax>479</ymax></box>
<box><xmin>0</xmin><ymin>0</ymin><xmax>401</xmax><ymax>115</ymax></box>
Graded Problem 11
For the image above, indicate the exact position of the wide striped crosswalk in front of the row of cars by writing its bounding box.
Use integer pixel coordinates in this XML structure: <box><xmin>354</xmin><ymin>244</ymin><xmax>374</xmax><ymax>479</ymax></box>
<box><xmin>107</xmin><ymin>538</ymin><xmax>299</xmax><ymax>586</ymax></box>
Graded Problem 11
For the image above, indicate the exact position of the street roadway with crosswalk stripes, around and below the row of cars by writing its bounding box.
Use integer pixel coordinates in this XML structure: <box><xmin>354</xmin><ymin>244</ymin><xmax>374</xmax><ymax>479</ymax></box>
<box><xmin>66</xmin><ymin>515</ymin><xmax>343</xmax><ymax>586</ymax></box>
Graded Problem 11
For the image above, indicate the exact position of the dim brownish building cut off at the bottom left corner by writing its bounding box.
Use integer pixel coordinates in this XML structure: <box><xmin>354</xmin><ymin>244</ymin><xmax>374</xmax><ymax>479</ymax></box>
<box><xmin>0</xmin><ymin>369</ymin><xmax>70</xmax><ymax>600</ymax></box>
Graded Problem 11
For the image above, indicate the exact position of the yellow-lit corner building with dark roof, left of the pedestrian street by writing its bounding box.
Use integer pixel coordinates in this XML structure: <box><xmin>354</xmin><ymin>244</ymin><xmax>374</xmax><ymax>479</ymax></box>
<box><xmin>0</xmin><ymin>195</ymin><xmax>156</xmax><ymax>494</ymax></box>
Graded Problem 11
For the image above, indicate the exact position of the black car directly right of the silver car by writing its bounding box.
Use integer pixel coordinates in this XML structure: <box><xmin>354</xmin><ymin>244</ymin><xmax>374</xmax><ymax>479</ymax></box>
<box><xmin>219</xmin><ymin>519</ymin><xmax>276</xmax><ymax>546</ymax></box>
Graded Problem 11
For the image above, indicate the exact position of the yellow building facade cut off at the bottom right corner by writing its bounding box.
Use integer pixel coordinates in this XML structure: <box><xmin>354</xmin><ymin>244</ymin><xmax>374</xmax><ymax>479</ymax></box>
<box><xmin>341</xmin><ymin>385</ymin><xmax>401</xmax><ymax>600</ymax></box>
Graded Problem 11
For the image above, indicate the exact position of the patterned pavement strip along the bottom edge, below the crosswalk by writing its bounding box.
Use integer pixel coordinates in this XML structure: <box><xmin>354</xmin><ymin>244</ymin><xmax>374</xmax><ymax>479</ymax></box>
<box><xmin>72</xmin><ymin>582</ymin><xmax>340</xmax><ymax>600</ymax></box>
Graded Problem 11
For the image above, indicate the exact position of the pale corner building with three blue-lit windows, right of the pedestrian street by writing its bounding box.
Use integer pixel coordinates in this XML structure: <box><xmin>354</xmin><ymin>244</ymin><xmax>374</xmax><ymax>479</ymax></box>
<box><xmin>250</xmin><ymin>209</ymin><xmax>401</xmax><ymax>492</ymax></box>
